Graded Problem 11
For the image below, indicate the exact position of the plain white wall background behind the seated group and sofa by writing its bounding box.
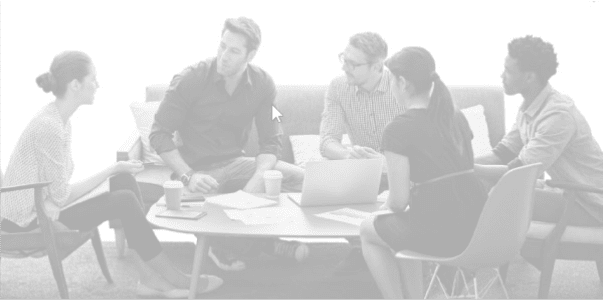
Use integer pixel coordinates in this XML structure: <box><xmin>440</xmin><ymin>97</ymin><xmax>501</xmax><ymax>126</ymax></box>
<box><xmin>0</xmin><ymin>0</ymin><xmax>603</xmax><ymax>180</ymax></box>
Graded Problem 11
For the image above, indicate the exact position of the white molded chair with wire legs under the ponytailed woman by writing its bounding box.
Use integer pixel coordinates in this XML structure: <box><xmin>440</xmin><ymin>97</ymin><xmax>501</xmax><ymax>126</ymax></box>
<box><xmin>396</xmin><ymin>163</ymin><xmax>541</xmax><ymax>299</ymax></box>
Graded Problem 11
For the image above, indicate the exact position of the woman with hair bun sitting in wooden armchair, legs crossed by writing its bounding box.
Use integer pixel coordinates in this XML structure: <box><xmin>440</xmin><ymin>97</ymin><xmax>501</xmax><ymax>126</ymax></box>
<box><xmin>0</xmin><ymin>51</ymin><xmax>222</xmax><ymax>298</ymax></box>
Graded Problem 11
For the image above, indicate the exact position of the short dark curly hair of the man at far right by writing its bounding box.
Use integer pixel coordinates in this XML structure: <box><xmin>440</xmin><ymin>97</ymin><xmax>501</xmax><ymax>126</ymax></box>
<box><xmin>508</xmin><ymin>35</ymin><xmax>559</xmax><ymax>83</ymax></box>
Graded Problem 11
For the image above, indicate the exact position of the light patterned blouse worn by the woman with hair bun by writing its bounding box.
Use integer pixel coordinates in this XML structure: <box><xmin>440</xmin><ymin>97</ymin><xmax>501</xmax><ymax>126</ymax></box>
<box><xmin>0</xmin><ymin>102</ymin><xmax>73</xmax><ymax>227</ymax></box>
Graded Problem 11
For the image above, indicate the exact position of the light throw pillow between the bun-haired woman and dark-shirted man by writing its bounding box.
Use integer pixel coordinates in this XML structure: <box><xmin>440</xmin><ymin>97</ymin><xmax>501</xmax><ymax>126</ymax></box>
<box><xmin>130</xmin><ymin>101</ymin><xmax>182</xmax><ymax>165</ymax></box>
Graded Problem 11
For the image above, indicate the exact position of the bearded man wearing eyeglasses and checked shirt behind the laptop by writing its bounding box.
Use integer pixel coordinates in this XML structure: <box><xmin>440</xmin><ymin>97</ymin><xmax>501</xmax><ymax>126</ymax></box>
<box><xmin>320</xmin><ymin>32</ymin><xmax>404</xmax><ymax>275</ymax></box>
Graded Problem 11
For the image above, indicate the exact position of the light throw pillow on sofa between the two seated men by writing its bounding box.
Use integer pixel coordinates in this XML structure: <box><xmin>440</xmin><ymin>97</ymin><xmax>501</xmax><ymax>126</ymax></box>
<box><xmin>289</xmin><ymin>134</ymin><xmax>351</xmax><ymax>168</ymax></box>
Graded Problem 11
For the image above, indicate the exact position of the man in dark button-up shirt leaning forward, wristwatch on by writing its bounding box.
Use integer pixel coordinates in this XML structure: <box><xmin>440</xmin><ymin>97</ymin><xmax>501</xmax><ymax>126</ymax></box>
<box><xmin>149</xmin><ymin>17</ymin><xmax>308</xmax><ymax>270</ymax></box>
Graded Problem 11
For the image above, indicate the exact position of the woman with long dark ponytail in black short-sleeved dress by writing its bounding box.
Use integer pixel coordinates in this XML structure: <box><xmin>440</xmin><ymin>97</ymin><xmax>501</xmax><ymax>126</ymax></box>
<box><xmin>360</xmin><ymin>47</ymin><xmax>487</xmax><ymax>299</ymax></box>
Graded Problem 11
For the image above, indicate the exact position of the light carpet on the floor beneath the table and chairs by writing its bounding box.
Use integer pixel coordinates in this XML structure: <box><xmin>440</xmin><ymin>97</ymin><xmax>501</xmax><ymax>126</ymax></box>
<box><xmin>0</xmin><ymin>242</ymin><xmax>603</xmax><ymax>299</ymax></box>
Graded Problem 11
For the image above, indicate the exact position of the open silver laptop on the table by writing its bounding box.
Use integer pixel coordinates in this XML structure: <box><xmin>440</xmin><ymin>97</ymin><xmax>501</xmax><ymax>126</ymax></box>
<box><xmin>288</xmin><ymin>159</ymin><xmax>383</xmax><ymax>206</ymax></box>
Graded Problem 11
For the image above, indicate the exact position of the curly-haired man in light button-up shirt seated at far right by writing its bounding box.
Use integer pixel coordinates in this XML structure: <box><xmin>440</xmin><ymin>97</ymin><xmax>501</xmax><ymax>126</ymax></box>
<box><xmin>475</xmin><ymin>36</ymin><xmax>603</xmax><ymax>226</ymax></box>
